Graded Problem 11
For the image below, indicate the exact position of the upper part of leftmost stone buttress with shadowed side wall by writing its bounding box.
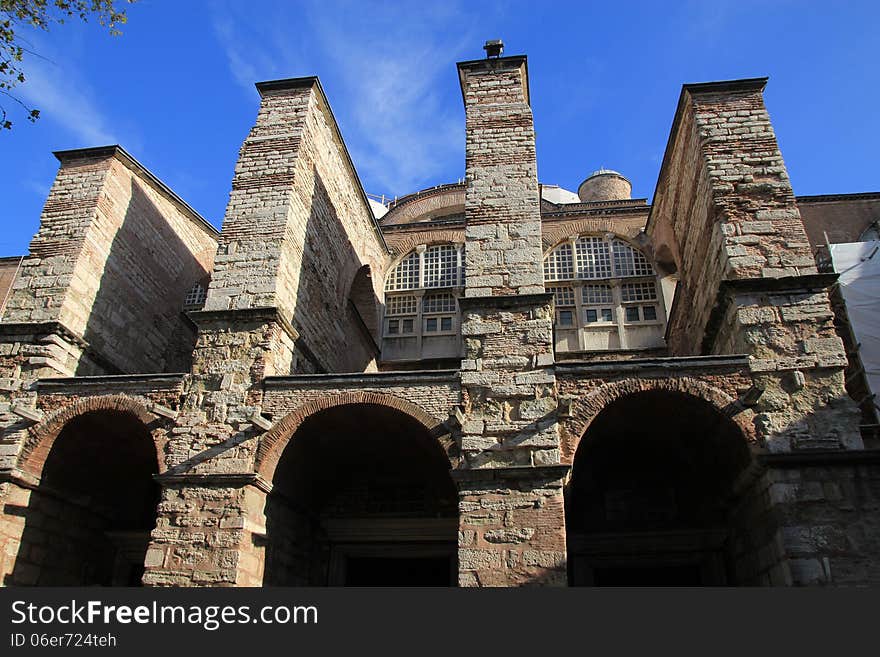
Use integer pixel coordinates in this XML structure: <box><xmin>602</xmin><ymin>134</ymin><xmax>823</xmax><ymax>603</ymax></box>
<box><xmin>4</xmin><ymin>149</ymin><xmax>216</xmax><ymax>373</ymax></box>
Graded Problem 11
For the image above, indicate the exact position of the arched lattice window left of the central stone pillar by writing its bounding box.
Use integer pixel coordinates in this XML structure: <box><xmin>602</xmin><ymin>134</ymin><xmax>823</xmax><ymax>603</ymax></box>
<box><xmin>384</xmin><ymin>244</ymin><xmax>464</xmax><ymax>338</ymax></box>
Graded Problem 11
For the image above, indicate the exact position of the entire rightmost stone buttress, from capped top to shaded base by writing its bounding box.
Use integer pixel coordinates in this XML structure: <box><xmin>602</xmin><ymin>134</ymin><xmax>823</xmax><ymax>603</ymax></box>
<box><xmin>647</xmin><ymin>78</ymin><xmax>871</xmax><ymax>584</ymax></box>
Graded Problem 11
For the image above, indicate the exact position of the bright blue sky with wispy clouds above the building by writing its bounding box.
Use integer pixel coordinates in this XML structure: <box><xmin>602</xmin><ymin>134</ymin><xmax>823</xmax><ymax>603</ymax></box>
<box><xmin>0</xmin><ymin>0</ymin><xmax>880</xmax><ymax>255</ymax></box>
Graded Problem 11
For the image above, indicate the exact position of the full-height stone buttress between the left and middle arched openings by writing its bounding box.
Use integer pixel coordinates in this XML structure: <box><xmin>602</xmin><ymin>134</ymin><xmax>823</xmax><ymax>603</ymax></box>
<box><xmin>144</xmin><ymin>77</ymin><xmax>387</xmax><ymax>586</ymax></box>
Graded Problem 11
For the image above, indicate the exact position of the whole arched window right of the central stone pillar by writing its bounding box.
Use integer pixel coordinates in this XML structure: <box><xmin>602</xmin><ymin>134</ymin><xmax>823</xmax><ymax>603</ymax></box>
<box><xmin>544</xmin><ymin>235</ymin><xmax>665</xmax><ymax>351</ymax></box>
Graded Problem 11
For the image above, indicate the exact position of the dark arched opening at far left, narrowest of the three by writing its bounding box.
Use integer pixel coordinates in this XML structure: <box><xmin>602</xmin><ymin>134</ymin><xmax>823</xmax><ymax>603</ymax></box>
<box><xmin>11</xmin><ymin>410</ymin><xmax>159</xmax><ymax>586</ymax></box>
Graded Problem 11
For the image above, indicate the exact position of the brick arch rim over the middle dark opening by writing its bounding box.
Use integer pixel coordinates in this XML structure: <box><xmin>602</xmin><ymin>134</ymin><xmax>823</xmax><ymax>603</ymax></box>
<box><xmin>254</xmin><ymin>391</ymin><xmax>451</xmax><ymax>481</ymax></box>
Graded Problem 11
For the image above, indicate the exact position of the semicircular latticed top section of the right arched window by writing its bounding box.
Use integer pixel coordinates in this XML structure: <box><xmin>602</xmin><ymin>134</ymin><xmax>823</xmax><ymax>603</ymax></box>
<box><xmin>544</xmin><ymin>237</ymin><xmax>654</xmax><ymax>281</ymax></box>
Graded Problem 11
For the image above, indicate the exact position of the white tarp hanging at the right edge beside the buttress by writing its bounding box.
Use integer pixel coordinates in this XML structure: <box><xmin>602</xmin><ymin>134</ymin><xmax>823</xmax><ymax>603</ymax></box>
<box><xmin>831</xmin><ymin>240</ymin><xmax>880</xmax><ymax>403</ymax></box>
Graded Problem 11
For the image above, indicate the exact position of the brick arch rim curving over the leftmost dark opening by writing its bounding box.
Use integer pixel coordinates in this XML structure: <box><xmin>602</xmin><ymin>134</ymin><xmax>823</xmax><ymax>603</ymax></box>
<box><xmin>18</xmin><ymin>394</ymin><xmax>165</xmax><ymax>479</ymax></box>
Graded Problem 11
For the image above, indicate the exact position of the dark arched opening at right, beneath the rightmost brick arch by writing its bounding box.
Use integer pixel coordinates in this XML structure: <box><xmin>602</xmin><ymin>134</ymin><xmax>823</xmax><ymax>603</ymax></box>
<box><xmin>566</xmin><ymin>390</ymin><xmax>778</xmax><ymax>586</ymax></box>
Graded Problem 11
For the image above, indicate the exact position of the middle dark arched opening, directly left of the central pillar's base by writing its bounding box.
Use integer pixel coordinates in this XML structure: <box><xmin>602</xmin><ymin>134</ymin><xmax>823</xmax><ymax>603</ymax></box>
<box><xmin>263</xmin><ymin>404</ymin><xmax>458</xmax><ymax>586</ymax></box>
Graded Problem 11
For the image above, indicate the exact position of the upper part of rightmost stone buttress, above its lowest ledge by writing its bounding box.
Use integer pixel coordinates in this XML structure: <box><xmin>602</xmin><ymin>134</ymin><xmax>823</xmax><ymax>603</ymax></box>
<box><xmin>648</xmin><ymin>79</ymin><xmax>861</xmax><ymax>451</ymax></box>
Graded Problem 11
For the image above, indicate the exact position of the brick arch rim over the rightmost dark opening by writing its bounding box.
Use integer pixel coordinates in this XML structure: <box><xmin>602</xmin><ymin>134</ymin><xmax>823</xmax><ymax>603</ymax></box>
<box><xmin>562</xmin><ymin>376</ymin><xmax>756</xmax><ymax>463</ymax></box>
